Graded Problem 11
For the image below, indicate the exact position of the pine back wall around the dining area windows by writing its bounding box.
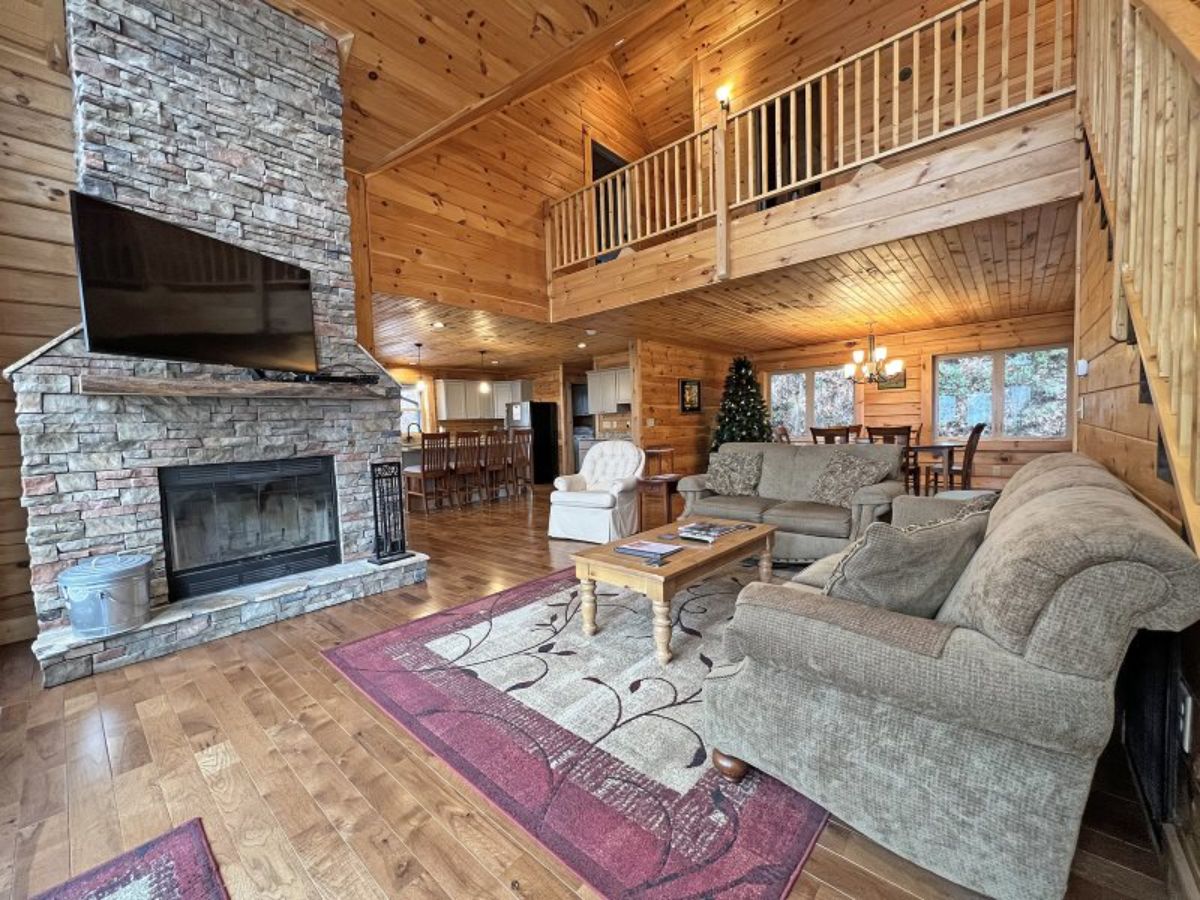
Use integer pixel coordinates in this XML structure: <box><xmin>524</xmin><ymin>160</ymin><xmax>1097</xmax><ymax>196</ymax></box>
<box><xmin>754</xmin><ymin>311</ymin><xmax>1074</xmax><ymax>487</ymax></box>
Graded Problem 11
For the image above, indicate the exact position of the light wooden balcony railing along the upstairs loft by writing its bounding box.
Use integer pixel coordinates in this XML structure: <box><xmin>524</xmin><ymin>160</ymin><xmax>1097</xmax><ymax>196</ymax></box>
<box><xmin>546</xmin><ymin>0</ymin><xmax>1075</xmax><ymax>272</ymax></box>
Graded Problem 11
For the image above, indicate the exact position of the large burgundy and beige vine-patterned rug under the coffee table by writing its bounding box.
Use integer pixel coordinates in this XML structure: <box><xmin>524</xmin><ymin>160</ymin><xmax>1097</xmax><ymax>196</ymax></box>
<box><xmin>326</xmin><ymin>572</ymin><xmax>826</xmax><ymax>900</ymax></box>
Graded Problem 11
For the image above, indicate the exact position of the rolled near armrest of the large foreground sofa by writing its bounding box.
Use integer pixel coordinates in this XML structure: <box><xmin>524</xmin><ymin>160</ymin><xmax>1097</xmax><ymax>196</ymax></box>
<box><xmin>725</xmin><ymin>583</ymin><xmax>1112</xmax><ymax>755</ymax></box>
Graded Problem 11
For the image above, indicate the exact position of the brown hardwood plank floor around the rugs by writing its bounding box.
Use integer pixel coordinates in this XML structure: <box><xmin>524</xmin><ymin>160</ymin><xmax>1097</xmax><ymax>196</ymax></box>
<box><xmin>0</xmin><ymin>493</ymin><xmax>1165</xmax><ymax>900</ymax></box>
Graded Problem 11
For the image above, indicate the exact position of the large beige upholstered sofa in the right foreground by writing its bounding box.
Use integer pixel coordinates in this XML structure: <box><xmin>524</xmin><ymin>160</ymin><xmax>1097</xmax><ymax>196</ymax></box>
<box><xmin>704</xmin><ymin>454</ymin><xmax>1200</xmax><ymax>900</ymax></box>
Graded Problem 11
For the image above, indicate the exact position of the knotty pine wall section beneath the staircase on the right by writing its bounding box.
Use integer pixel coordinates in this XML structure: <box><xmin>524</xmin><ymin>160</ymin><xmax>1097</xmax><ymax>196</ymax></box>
<box><xmin>1076</xmin><ymin>177</ymin><xmax>1180</xmax><ymax>527</ymax></box>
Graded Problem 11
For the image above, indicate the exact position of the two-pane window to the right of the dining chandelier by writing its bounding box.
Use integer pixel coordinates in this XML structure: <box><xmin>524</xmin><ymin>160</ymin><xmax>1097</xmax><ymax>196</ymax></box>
<box><xmin>934</xmin><ymin>347</ymin><xmax>1070</xmax><ymax>438</ymax></box>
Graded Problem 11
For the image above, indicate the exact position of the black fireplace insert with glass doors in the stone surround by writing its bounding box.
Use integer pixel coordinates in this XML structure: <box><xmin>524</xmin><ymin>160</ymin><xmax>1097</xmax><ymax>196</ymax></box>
<box><xmin>158</xmin><ymin>456</ymin><xmax>342</xmax><ymax>600</ymax></box>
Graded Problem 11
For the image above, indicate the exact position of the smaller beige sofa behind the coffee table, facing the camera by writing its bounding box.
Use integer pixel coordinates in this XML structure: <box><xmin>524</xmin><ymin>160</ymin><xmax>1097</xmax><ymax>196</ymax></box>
<box><xmin>679</xmin><ymin>443</ymin><xmax>905</xmax><ymax>563</ymax></box>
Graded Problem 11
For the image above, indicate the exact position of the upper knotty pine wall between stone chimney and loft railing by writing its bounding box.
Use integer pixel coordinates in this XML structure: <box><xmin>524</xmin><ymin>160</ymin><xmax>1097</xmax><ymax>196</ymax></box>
<box><xmin>367</xmin><ymin>61</ymin><xmax>650</xmax><ymax>320</ymax></box>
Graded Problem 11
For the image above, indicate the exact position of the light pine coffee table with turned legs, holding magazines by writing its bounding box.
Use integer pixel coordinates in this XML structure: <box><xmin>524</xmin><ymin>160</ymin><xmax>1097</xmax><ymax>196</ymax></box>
<box><xmin>571</xmin><ymin>516</ymin><xmax>775</xmax><ymax>665</ymax></box>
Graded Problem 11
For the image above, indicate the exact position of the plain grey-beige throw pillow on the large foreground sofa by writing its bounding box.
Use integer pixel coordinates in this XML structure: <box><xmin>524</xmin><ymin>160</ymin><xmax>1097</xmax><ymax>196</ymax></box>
<box><xmin>823</xmin><ymin>510</ymin><xmax>988</xmax><ymax>619</ymax></box>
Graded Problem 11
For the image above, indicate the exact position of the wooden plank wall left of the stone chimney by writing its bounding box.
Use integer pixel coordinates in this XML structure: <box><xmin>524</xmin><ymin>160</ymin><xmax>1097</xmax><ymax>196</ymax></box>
<box><xmin>0</xmin><ymin>0</ymin><xmax>79</xmax><ymax>643</ymax></box>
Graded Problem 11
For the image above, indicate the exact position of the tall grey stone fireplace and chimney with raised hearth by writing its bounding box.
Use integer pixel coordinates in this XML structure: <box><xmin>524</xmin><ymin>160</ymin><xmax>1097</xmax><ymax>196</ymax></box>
<box><xmin>5</xmin><ymin>0</ymin><xmax>426</xmax><ymax>684</ymax></box>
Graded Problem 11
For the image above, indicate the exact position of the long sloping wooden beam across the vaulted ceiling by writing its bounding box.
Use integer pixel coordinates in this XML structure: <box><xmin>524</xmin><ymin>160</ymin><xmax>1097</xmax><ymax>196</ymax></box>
<box><xmin>362</xmin><ymin>0</ymin><xmax>683</xmax><ymax>178</ymax></box>
